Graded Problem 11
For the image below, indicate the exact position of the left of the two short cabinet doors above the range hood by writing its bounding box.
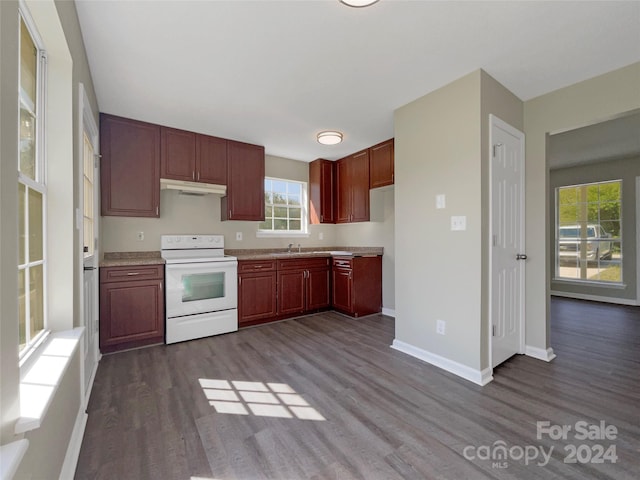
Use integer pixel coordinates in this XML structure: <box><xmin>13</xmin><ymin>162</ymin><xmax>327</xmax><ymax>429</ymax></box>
<box><xmin>160</xmin><ymin>127</ymin><xmax>196</xmax><ymax>182</ymax></box>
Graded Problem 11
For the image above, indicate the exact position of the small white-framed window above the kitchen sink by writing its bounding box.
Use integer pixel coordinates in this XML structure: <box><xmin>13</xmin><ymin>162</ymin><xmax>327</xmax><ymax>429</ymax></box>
<box><xmin>259</xmin><ymin>177</ymin><xmax>308</xmax><ymax>235</ymax></box>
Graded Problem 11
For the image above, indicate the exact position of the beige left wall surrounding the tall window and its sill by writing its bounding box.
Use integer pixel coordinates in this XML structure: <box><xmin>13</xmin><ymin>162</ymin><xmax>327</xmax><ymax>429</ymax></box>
<box><xmin>0</xmin><ymin>1</ymin><xmax>97</xmax><ymax>478</ymax></box>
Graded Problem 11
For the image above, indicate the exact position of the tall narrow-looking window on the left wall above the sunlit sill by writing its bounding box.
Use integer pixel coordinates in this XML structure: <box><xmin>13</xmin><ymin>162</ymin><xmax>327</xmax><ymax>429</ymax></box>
<box><xmin>17</xmin><ymin>12</ymin><xmax>47</xmax><ymax>358</ymax></box>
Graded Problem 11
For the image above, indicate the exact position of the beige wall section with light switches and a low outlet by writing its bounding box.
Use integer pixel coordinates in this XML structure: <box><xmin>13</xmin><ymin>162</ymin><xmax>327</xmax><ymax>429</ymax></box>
<box><xmin>395</xmin><ymin>71</ymin><xmax>482</xmax><ymax>370</ymax></box>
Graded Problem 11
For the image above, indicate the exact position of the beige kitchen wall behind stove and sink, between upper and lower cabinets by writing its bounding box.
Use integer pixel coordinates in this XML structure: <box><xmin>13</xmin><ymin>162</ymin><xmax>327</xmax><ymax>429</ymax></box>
<box><xmin>100</xmin><ymin>155</ymin><xmax>395</xmax><ymax>310</ymax></box>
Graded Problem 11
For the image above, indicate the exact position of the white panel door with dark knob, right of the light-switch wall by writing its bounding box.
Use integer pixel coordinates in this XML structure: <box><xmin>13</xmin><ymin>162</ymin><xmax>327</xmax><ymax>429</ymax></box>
<box><xmin>490</xmin><ymin>115</ymin><xmax>526</xmax><ymax>367</ymax></box>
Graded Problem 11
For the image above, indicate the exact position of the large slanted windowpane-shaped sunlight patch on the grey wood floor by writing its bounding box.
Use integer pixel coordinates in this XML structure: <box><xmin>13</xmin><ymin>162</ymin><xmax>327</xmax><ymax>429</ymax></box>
<box><xmin>198</xmin><ymin>378</ymin><xmax>326</xmax><ymax>421</ymax></box>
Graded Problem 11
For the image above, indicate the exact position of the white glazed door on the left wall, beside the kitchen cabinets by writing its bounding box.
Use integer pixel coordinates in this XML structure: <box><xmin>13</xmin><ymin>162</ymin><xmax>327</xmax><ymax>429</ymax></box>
<box><xmin>78</xmin><ymin>85</ymin><xmax>99</xmax><ymax>395</ymax></box>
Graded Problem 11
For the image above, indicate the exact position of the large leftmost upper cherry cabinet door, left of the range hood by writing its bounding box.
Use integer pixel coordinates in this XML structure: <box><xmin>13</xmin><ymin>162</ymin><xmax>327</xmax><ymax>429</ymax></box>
<box><xmin>100</xmin><ymin>114</ymin><xmax>160</xmax><ymax>217</ymax></box>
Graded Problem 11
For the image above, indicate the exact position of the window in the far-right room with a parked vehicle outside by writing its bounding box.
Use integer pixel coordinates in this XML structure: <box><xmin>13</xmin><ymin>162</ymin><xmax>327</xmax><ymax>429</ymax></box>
<box><xmin>555</xmin><ymin>180</ymin><xmax>622</xmax><ymax>283</ymax></box>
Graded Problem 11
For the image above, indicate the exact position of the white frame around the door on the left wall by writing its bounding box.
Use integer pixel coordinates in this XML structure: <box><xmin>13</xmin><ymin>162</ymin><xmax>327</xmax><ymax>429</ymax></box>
<box><xmin>75</xmin><ymin>82</ymin><xmax>101</xmax><ymax>403</ymax></box>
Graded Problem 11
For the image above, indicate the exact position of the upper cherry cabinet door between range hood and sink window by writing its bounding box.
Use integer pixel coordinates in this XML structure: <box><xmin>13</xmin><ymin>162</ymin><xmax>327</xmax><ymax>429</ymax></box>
<box><xmin>220</xmin><ymin>140</ymin><xmax>264</xmax><ymax>221</ymax></box>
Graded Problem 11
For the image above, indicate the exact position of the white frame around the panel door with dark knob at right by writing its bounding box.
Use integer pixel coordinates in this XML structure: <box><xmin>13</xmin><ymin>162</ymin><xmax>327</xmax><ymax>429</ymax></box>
<box><xmin>487</xmin><ymin>114</ymin><xmax>526</xmax><ymax>373</ymax></box>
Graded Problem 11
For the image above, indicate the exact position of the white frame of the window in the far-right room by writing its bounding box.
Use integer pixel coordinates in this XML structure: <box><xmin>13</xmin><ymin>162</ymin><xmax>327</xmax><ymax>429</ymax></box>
<box><xmin>553</xmin><ymin>178</ymin><xmax>624</xmax><ymax>288</ymax></box>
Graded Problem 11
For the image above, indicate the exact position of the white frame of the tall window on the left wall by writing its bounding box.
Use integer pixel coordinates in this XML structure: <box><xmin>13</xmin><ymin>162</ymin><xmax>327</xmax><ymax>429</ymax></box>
<box><xmin>16</xmin><ymin>2</ymin><xmax>50</xmax><ymax>366</ymax></box>
